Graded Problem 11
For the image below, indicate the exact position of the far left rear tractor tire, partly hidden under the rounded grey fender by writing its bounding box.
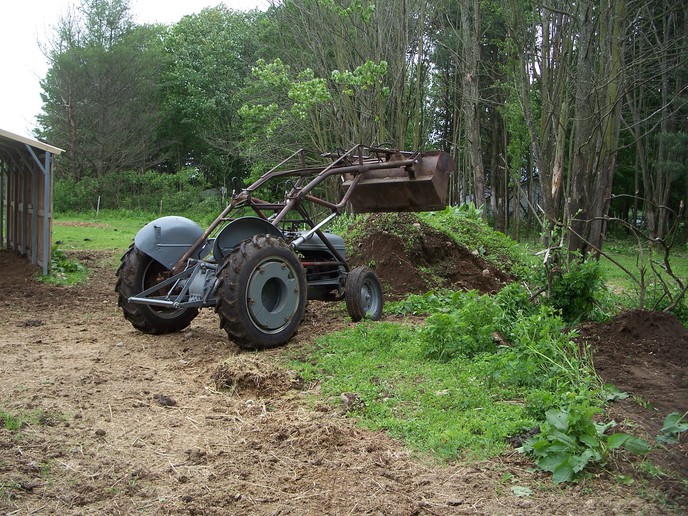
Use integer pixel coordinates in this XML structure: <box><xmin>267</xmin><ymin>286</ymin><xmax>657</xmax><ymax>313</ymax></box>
<box><xmin>115</xmin><ymin>245</ymin><xmax>198</xmax><ymax>335</ymax></box>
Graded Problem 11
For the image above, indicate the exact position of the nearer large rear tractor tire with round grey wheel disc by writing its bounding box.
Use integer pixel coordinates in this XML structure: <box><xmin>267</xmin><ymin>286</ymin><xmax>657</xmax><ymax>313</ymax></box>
<box><xmin>215</xmin><ymin>235</ymin><xmax>308</xmax><ymax>349</ymax></box>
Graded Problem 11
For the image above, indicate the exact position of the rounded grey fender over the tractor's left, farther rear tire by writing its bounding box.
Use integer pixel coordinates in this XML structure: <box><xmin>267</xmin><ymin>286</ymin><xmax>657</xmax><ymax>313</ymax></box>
<box><xmin>134</xmin><ymin>216</ymin><xmax>207</xmax><ymax>269</ymax></box>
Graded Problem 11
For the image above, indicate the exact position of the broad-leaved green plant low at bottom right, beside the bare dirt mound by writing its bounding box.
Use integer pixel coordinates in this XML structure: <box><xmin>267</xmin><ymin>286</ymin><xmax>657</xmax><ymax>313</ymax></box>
<box><xmin>519</xmin><ymin>400</ymin><xmax>650</xmax><ymax>484</ymax></box>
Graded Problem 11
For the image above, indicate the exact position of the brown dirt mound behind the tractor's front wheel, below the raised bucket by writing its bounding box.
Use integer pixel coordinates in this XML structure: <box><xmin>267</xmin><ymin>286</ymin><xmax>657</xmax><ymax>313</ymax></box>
<box><xmin>349</xmin><ymin>213</ymin><xmax>510</xmax><ymax>299</ymax></box>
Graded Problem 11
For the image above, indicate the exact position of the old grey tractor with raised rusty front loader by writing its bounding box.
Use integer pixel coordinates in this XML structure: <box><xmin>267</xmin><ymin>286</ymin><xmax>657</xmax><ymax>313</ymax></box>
<box><xmin>116</xmin><ymin>145</ymin><xmax>454</xmax><ymax>349</ymax></box>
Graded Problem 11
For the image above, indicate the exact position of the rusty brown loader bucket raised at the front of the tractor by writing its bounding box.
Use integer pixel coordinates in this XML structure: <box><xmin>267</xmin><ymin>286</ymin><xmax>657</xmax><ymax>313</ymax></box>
<box><xmin>342</xmin><ymin>151</ymin><xmax>456</xmax><ymax>213</ymax></box>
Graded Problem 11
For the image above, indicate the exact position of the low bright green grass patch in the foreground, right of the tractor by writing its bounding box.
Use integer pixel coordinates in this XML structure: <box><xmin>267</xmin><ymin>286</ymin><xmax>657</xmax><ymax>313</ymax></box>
<box><xmin>292</xmin><ymin>323</ymin><xmax>548</xmax><ymax>459</ymax></box>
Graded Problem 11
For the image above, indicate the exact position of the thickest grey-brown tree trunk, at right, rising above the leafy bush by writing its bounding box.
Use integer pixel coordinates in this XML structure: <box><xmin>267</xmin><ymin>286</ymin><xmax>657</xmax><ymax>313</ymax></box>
<box><xmin>567</xmin><ymin>0</ymin><xmax>625</xmax><ymax>256</ymax></box>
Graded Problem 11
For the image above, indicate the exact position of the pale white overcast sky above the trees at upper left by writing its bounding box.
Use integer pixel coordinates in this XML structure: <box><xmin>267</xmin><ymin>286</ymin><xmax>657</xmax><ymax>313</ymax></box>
<box><xmin>0</xmin><ymin>0</ymin><xmax>269</xmax><ymax>137</ymax></box>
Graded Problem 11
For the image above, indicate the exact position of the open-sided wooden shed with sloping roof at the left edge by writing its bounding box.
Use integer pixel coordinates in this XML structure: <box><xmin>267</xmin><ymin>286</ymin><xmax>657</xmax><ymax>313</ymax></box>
<box><xmin>0</xmin><ymin>129</ymin><xmax>63</xmax><ymax>274</ymax></box>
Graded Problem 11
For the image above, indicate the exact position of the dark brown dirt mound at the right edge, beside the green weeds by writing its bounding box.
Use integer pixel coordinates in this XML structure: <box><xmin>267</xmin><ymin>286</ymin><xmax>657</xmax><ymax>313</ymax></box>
<box><xmin>579</xmin><ymin>310</ymin><xmax>688</xmax><ymax>507</ymax></box>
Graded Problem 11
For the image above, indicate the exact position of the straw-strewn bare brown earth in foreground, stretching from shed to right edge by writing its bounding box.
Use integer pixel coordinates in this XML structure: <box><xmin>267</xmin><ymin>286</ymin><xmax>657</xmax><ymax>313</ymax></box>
<box><xmin>0</xmin><ymin>248</ymin><xmax>688</xmax><ymax>515</ymax></box>
